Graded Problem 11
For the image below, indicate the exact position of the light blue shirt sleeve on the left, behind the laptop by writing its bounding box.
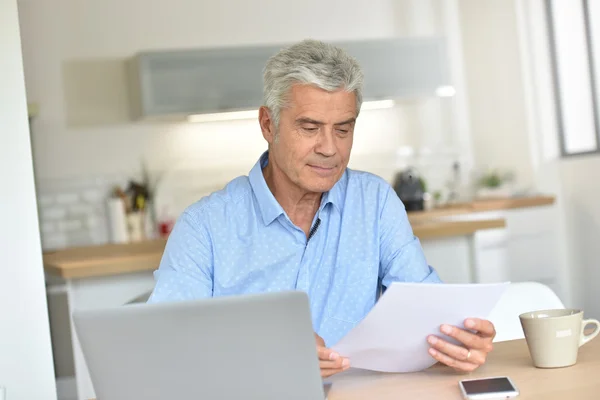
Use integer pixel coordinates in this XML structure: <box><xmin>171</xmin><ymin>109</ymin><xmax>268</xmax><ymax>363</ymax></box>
<box><xmin>148</xmin><ymin>212</ymin><xmax>213</xmax><ymax>303</ymax></box>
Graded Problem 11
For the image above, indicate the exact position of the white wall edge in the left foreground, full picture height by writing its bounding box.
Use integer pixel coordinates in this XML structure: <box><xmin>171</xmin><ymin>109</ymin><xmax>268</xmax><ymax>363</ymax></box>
<box><xmin>0</xmin><ymin>0</ymin><xmax>56</xmax><ymax>400</ymax></box>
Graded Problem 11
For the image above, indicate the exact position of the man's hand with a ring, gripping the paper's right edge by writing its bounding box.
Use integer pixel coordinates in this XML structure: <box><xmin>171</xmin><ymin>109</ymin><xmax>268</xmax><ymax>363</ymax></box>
<box><xmin>427</xmin><ymin>318</ymin><xmax>496</xmax><ymax>372</ymax></box>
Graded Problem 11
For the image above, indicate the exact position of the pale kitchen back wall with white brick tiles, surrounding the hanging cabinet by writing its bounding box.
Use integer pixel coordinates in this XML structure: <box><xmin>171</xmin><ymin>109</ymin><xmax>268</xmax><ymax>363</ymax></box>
<box><xmin>19</xmin><ymin>0</ymin><xmax>470</xmax><ymax>249</ymax></box>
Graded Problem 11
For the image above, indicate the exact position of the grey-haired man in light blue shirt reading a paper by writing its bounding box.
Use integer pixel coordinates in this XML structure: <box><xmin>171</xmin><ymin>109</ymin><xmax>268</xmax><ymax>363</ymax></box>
<box><xmin>149</xmin><ymin>40</ymin><xmax>495</xmax><ymax>377</ymax></box>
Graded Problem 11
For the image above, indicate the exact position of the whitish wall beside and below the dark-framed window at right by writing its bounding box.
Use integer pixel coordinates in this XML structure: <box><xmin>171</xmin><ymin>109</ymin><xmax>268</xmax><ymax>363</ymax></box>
<box><xmin>516</xmin><ymin>0</ymin><xmax>600</xmax><ymax>318</ymax></box>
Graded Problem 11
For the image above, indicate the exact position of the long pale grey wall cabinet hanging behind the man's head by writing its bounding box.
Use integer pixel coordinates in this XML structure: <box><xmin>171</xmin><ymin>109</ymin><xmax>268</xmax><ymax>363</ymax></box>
<box><xmin>128</xmin><ymin>36</ymin><xmax>451</xmax><ymax>119</ymax></box>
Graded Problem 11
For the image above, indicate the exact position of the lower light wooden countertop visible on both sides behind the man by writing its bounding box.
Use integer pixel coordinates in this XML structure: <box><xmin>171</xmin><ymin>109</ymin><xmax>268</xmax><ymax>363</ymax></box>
<box><xmin>44</xmin><ymin>219</ymin><xmax>505</xmax><ymax>279</ymax></box>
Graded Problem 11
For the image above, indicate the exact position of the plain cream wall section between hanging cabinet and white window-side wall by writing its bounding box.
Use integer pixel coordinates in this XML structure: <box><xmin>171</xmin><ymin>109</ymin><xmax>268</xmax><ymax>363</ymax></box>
<box><xmin>458</xmin><ymin>0</ymin><xmax>534</xmax><ymax>188</ymax></box>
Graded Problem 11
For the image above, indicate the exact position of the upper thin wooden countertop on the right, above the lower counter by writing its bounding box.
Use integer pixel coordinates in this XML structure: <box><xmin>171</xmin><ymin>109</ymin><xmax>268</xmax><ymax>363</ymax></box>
<box><xmin>409</xmin><ymin>195</ymin><xmax>555</xmax><ymax>223</ymax></box>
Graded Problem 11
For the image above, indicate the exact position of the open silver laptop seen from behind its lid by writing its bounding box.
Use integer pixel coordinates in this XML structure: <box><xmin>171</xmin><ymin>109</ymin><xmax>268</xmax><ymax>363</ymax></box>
<box><xmin>73</xmin><ymin>292</ymin><xmax>325</xmax><ymax>400</ymax></box>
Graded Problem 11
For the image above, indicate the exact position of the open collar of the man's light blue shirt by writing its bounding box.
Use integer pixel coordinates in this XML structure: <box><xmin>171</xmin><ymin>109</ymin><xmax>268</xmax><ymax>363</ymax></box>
<box><xmin>248</xmin><ymin>151</ymin><xmax>348</xmax><ymax>225</ymax></box>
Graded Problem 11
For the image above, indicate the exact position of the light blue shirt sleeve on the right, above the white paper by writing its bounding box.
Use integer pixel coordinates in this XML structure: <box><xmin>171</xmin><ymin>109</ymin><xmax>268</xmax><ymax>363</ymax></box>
<box><xmin>379</xmin><ymin>186</ymin><xmax>441</xmax><ymax>287</ymax></box>
